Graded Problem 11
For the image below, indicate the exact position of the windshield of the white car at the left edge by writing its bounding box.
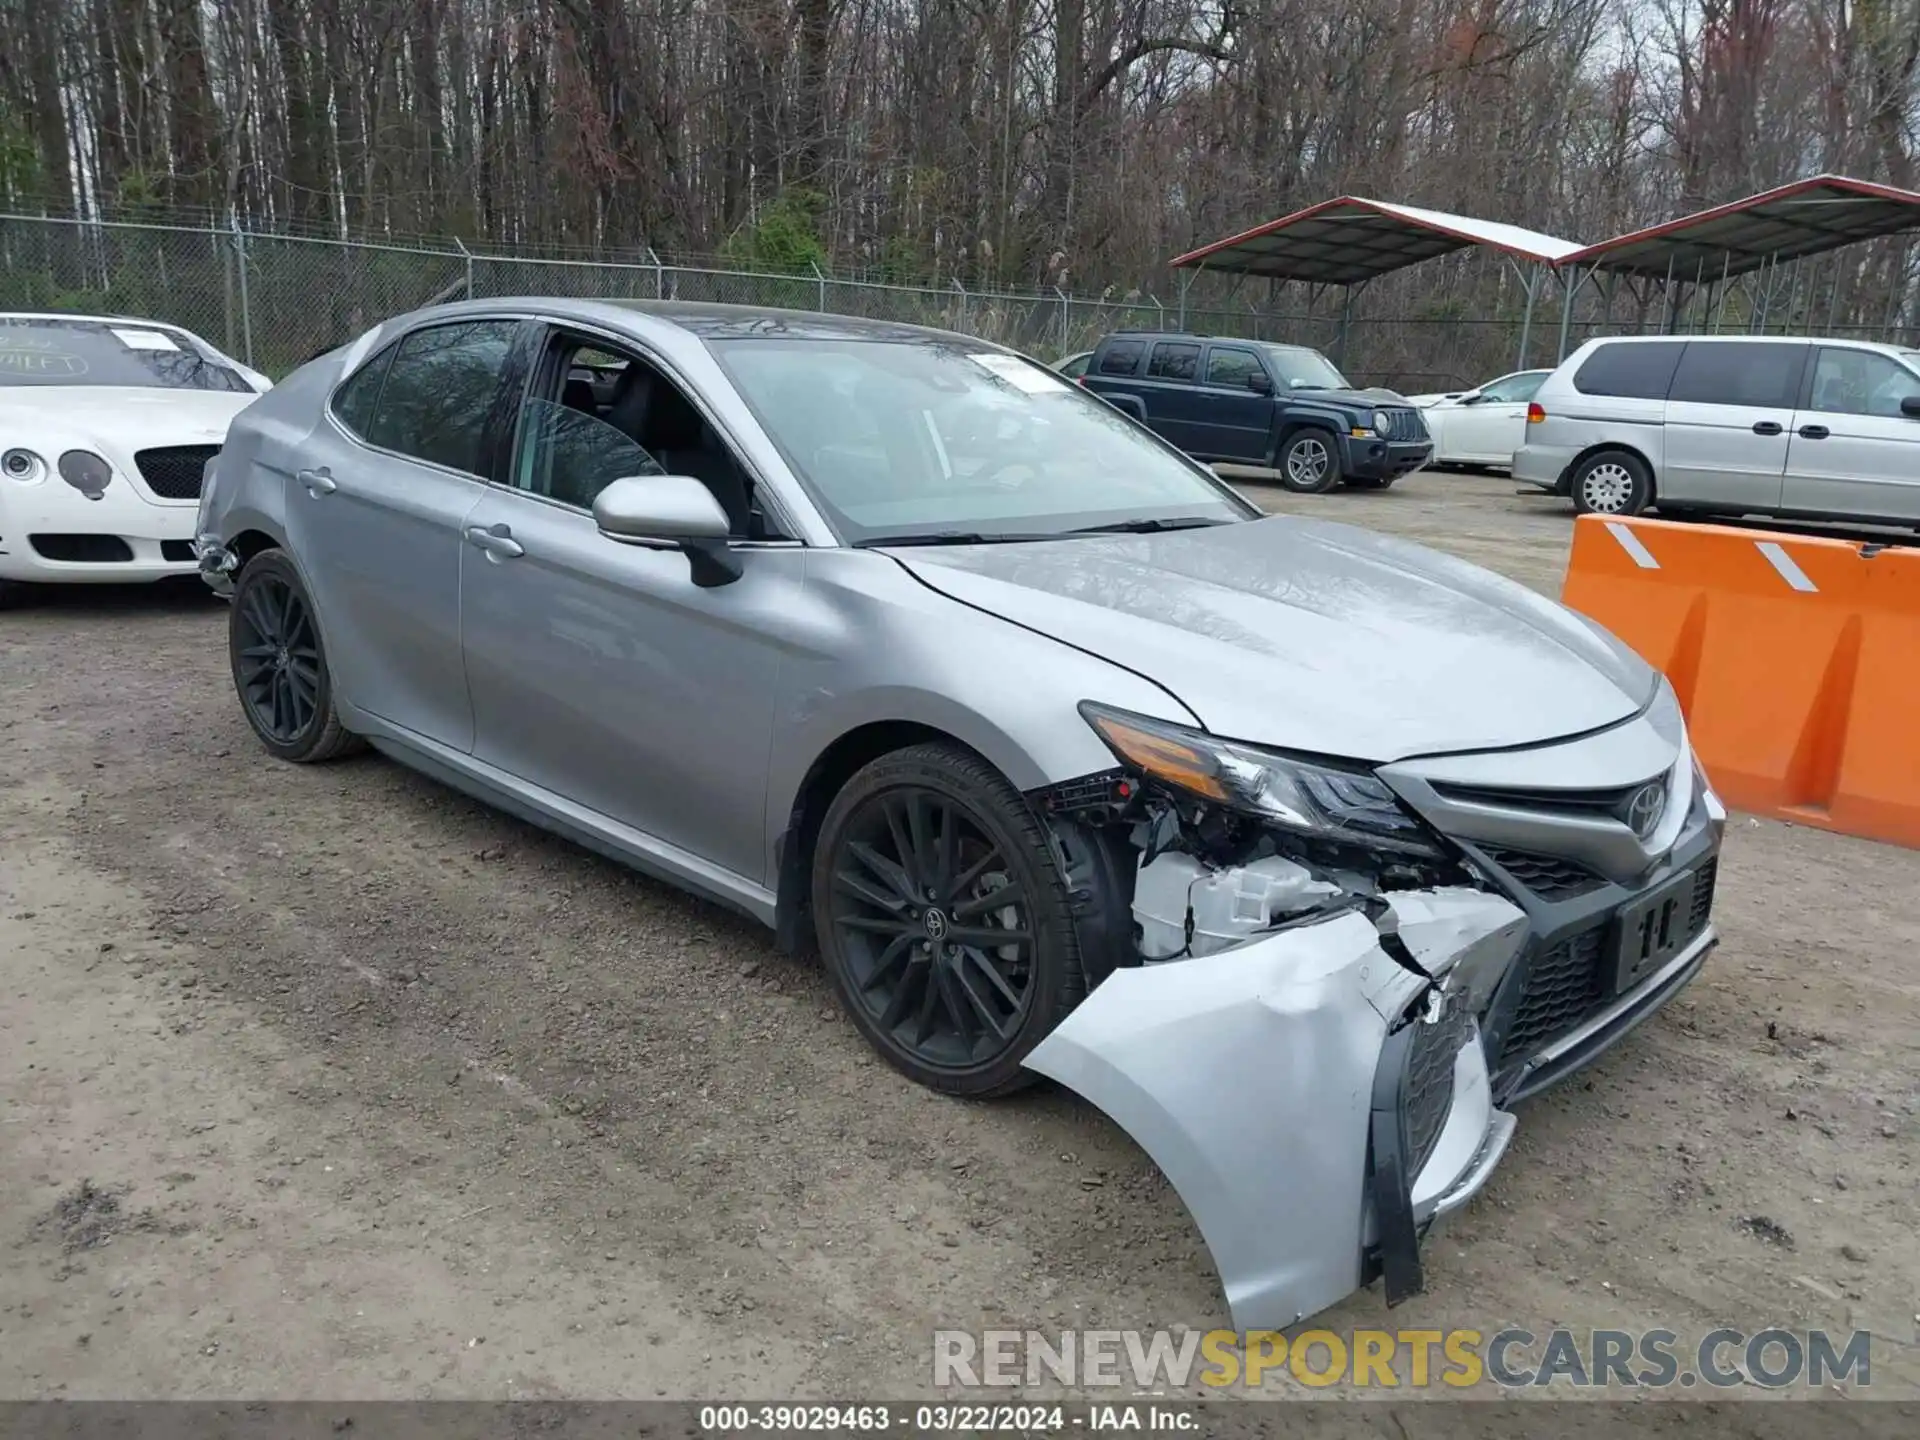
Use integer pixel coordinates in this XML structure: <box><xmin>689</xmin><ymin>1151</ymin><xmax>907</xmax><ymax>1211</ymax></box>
<box><xmin>0</xmin><ymin>315</ymin><xmax>253</xmax><ymax>396</ymax></box>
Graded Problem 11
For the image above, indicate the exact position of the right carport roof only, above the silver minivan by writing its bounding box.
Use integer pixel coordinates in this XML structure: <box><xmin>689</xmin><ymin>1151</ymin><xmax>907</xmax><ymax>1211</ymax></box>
<box><xmin>1561</xmin><ymin>175</ymin><xmax>1920</xmax><ymax>280</ymax></box>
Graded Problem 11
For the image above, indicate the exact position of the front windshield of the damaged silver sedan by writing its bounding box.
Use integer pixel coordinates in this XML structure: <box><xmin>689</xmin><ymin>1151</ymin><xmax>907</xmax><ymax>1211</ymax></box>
<box><xmin>708</xmin><ymin>338</ymin><xmax>1258</xmax><ymax>543</ymax></box>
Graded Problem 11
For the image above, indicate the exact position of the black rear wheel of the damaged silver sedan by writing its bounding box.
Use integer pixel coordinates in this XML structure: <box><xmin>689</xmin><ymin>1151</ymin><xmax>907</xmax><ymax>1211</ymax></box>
<box><xmin>227</xmin><ymin>549</ymin><xmax>359</xmax><ymax>764</ymax></box>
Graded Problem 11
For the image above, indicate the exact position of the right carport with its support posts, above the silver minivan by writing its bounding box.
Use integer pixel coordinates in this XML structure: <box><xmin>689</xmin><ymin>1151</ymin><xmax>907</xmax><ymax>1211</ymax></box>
<box><xmin>1557</xmin><ymin>175</ymin><xmax>1920</xmax><ymax>359</ymax></box>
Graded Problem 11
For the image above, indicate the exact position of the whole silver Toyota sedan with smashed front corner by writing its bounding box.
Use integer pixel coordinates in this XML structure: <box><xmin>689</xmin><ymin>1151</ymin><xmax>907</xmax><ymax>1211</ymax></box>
<box><xmin>198</xmin><ymin>300</ymin><xmax>1724</xmax><ymax>1329</ymax></box>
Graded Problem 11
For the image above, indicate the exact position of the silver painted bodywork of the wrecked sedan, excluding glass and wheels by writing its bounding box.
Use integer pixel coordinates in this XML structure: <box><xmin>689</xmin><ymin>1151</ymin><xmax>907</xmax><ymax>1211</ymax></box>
<box><xmin>196</xmin><ymin>300</ymin><xmax>1724</xmax><ymax>1325</ymax></box>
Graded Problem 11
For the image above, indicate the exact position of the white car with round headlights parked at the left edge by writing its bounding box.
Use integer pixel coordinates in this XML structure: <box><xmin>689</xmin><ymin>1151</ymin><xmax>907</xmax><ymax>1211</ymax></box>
<box><xmin>0</xmin><ymin>313</ymin><xmax>273</xmax><ymax>597</ymax></box>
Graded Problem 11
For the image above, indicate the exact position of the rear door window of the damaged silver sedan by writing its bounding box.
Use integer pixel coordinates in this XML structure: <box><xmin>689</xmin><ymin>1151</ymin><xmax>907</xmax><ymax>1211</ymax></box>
<box><xmin>367</xmin><ymin>321</ymin><xmax>518</xmax><ymax>474</ymax></box>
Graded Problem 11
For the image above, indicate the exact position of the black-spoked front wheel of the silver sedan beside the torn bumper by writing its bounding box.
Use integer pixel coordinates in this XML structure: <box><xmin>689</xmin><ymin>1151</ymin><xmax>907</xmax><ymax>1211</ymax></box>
<box><xmin>812</xmin><ymin>743</ymin><xmax>1087</xmax><ymax>1098</ymax></box>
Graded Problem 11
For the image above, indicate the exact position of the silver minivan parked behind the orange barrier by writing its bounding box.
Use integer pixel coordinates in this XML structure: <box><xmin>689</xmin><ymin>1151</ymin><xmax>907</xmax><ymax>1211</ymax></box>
<box><xmin>1513</xmin><ymin>336</ymin><xmax>1920</xmax><ymax>524</ymax></box>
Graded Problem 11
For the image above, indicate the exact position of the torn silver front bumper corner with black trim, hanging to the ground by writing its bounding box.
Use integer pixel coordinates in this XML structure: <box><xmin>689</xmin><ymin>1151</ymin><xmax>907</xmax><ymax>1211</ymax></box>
<box><xmin>1025</xmin><ymin>887</ymin><xmax>1526</xmax><ymax>1331</ymax></box>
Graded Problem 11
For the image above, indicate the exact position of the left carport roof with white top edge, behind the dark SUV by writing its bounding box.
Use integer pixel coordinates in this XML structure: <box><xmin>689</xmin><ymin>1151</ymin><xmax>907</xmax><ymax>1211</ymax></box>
<box><xmin>1171</xmin><ymin>196</ymin><xmax>1580</xmax><ymax>284</ymax></box>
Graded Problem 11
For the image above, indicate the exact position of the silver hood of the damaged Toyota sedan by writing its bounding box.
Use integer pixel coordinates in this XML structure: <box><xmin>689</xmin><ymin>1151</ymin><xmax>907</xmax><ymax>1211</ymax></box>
<box><xmin>891</xmin><ymin>516</ymin><xmax>1657</xmax><ymax>764</ymax></box>
